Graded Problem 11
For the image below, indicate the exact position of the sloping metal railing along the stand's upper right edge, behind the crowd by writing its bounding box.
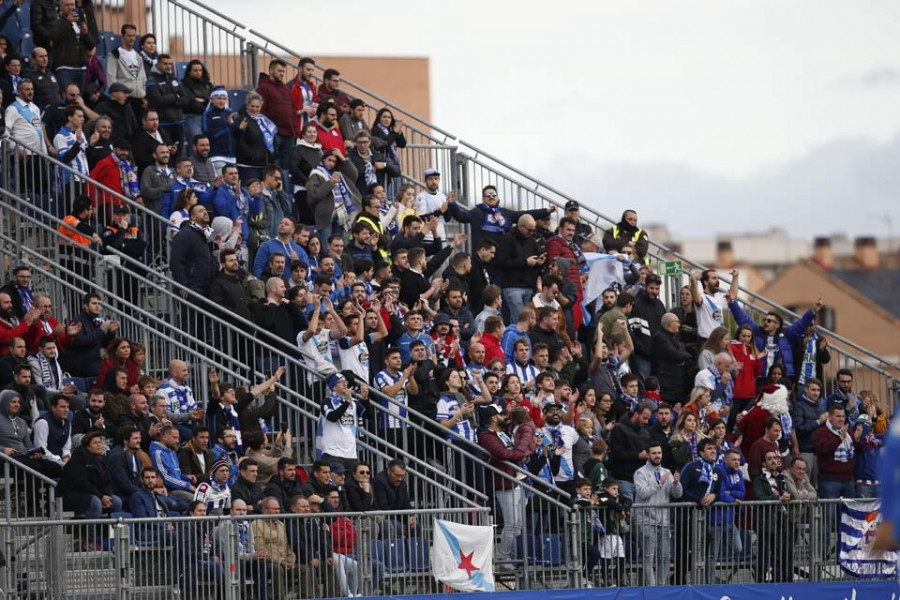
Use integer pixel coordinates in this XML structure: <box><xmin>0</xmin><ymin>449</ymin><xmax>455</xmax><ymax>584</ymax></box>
<box><xmin>75</xmin><ymin>0</ymin><xmax>900</xmax><ymax>404</ymax></box>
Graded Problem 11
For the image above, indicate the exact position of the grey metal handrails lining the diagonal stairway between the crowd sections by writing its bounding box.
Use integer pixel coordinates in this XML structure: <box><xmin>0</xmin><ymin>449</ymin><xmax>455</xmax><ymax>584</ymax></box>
<box><xmin>0</xmin><ymin>142</ymin><xmax>541</xmax><ymax>510</ymax></box>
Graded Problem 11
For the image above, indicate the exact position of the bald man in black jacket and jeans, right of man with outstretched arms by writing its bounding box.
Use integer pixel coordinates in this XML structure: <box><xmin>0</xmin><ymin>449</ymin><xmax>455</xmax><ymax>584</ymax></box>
<box><xmin>496</xmin><ymin>214</ymin><xmax>547</xmax><ymax>323</ymax></box>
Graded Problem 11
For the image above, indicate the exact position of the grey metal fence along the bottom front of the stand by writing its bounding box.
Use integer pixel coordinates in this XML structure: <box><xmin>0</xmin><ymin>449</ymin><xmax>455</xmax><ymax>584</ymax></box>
<box><xmin>0</xmin><ymin>500</ymin><xmax>892</xmax><ymax>599</ymax></box>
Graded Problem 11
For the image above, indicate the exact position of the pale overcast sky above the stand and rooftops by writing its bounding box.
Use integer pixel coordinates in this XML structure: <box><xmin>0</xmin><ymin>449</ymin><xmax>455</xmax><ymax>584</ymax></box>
<box><xmin>216</xmin><ymin>0</ymin><xmax>900</xmax><ymax>237</ymax></box>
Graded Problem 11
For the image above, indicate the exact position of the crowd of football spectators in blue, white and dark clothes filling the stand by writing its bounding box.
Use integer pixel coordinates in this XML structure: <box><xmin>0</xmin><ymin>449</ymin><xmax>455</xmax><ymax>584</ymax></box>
<box><xmin>0</xmin><ymin>0</ymin><xmax>890</xmax><ymax>595</ymax></box>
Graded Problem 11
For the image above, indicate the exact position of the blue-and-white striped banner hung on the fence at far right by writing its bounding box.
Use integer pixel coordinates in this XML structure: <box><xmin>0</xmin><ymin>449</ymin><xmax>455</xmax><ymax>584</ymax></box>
<box><xmin>838</xmin><ymin>498</ymin><xmax>898</xmax><ymax>578</ymax></box>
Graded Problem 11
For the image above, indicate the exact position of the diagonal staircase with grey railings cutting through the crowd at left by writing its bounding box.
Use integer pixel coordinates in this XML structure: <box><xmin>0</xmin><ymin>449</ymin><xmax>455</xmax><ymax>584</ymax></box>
<box><xmin>0</xmin><ymin>140</ymin><xmax>566</xmax><ymax>536</ymax></box>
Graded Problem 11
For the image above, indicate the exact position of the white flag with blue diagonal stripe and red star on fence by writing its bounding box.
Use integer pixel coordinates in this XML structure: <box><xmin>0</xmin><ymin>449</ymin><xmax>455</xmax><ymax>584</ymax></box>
<box><xmin>431</xmin><ymin>519</ymin><xmax>494</xmax><ymax>592</ymax></box>
